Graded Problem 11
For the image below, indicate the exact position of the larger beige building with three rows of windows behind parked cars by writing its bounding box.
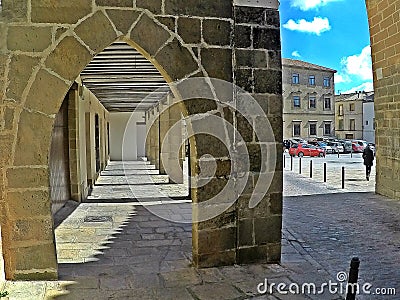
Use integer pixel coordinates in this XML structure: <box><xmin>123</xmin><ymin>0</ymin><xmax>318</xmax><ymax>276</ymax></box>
<box><xmin>282</xmin><ymin>58</ymin><xmax>336</xmax><ymax>139</ymax></box>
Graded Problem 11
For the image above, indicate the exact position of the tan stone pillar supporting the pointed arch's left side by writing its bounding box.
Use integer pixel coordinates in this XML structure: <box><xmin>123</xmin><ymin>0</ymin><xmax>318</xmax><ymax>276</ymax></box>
<box><xmin>0</xmin><ymin>110</ymin><xmax>59</xmax><ymax>280</ymax></box>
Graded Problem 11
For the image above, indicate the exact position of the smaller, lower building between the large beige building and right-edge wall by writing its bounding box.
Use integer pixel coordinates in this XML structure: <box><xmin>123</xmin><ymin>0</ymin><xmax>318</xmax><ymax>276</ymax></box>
<box><xmin>335</xmin><ymin>91</ymin><xmax>375</xmax><ymax>143</ymax></box>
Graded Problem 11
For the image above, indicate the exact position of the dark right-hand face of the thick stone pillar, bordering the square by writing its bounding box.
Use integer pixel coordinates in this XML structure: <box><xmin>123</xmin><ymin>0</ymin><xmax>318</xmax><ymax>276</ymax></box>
<box><xmin>234</xmin><ymin>1</ymin><xmax>283</xmax><ymax>263</ymax></box>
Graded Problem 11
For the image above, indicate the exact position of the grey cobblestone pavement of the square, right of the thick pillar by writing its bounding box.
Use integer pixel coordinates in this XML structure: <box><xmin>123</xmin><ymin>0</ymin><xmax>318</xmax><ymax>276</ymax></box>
<box><xmin>283</xmin><ymin>156</ymin><xmax>400</xmax><ymax>299</ymax></box>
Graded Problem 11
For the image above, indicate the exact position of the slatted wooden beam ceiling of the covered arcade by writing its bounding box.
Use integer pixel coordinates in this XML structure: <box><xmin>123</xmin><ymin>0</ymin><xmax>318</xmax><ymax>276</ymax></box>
<box><xmin>81</xmin><ymin>42</ymin><xmax>170</xmax><ymax>112</ymax></box>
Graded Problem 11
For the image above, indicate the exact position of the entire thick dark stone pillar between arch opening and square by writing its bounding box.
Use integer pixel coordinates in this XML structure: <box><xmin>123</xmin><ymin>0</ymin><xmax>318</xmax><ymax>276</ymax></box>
<box><xmin>192</xmin><ymin>0</ymin><xmax>283</xmax><ymax>267</ymax></box>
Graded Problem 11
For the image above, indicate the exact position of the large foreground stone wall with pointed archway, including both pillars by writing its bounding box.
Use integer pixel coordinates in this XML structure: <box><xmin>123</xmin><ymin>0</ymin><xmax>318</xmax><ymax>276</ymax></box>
<box><xmin>0</xmin><ymin>0</ymin><xmax>282</xmax><ymax>279</ymax></box>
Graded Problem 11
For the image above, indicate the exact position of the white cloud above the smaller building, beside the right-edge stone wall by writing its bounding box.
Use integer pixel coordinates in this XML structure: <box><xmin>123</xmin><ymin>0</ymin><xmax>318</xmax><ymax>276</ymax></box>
<box><xmin>341</xmin><ymin>46</ymin><xmax>372</xmax><ymax>80</ymax></box>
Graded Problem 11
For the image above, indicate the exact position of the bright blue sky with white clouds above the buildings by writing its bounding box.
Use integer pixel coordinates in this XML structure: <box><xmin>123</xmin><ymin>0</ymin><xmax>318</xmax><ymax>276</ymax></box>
<box><xmin>279</xmin><ymin>0</ymin><xmax>373</xmax><ymax>93</ymax></box>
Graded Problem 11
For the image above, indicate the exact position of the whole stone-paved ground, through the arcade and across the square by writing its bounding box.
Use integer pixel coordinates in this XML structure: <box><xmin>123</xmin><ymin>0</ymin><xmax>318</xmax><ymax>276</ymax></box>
<box><xmin>0</xmin><ymin>157</ymin><xmax>400</xmax><ymax>300</ymax></box>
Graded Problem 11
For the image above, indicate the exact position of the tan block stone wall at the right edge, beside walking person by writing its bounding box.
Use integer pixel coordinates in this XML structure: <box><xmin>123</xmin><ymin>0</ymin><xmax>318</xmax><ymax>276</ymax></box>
<box><xmin>366</xmin><ymin>0</ymin><xmax>400</xmax><ymax>198</ymax></box>
